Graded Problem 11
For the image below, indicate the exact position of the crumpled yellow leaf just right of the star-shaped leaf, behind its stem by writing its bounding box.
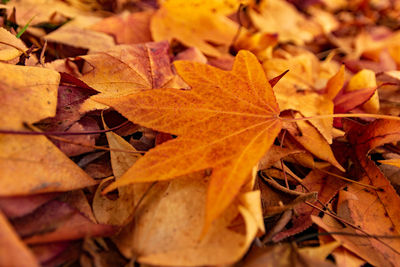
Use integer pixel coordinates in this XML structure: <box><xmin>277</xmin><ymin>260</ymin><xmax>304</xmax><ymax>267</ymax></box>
<box><xmin>263</xmin><ymin>48</ymin><xmax>338</xmax><ymax>144</ymax></box>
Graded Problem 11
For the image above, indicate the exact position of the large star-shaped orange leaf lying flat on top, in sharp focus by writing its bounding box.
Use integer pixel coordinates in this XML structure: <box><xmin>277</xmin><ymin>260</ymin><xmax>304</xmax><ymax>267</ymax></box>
<box><xmin>95</xmin><ymin>51</ymin><xmax>282</xmax><ymax>229</ymax></box>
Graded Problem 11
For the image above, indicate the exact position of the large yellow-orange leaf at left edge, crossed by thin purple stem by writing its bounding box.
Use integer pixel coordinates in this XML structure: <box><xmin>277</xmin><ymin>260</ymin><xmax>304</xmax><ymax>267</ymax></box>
<box><xmin>0</xmin><ymin>63</ymin><xmax>97</xmax><ymax>196</ymax></box>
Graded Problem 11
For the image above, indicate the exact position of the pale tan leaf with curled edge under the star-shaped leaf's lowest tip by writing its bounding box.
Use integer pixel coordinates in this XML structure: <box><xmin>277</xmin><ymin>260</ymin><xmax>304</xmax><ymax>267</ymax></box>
<box><xmin>114</xmin><ymin>172</ymin><xmax>263</xmax><ymax>266</ymax></box>
